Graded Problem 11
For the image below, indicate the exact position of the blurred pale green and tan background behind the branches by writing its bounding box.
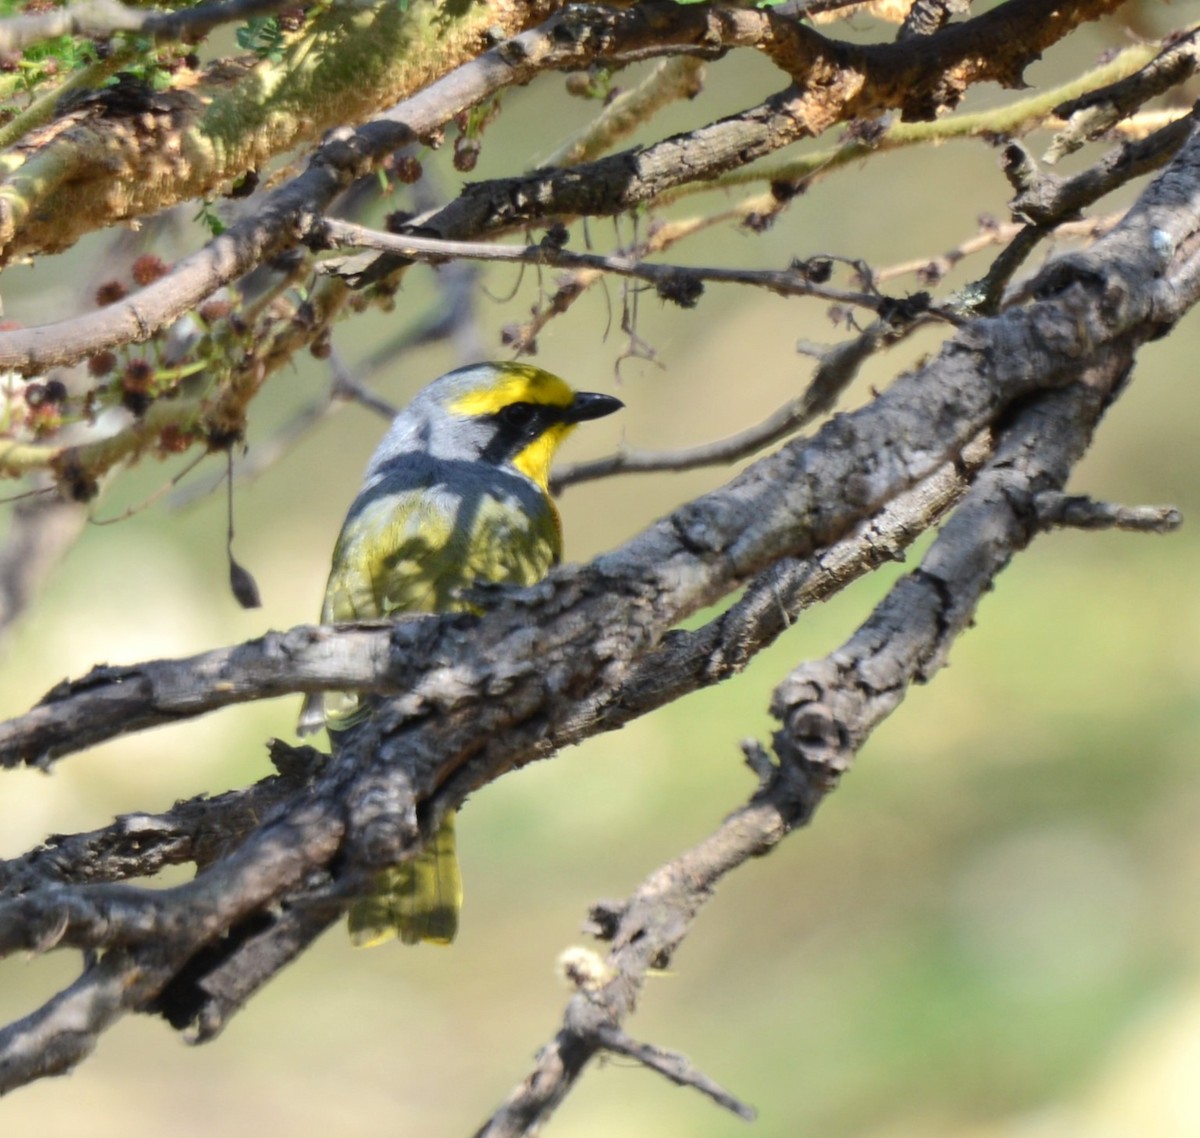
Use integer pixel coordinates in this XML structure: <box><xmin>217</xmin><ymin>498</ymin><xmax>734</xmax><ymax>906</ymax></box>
<box><xmin>0</xmin><ymin>5</ymin><xmax>1200</xmax><ymax>1138</ymax></box>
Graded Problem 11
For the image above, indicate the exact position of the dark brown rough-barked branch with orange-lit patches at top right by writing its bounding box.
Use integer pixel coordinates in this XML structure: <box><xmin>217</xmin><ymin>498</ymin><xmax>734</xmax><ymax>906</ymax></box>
<box><xmin>307</xmin><ymin>0</ymin><xmax>1120</xmax><ymax>283</ymax></box>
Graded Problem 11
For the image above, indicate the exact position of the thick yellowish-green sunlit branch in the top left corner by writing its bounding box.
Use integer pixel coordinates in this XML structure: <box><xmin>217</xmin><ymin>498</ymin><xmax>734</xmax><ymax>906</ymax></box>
<box><xmin>0</xmin><ymin>0</ymin><xmax>563</xmax><ymax>263</ymax></box>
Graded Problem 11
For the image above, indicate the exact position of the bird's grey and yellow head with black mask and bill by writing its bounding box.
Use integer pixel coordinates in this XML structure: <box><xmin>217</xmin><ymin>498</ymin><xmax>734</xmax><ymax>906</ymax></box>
<box><xmin>368</xmin><ymin>364</ymin><xmax>624</xmax><ymax>490</ymax></box>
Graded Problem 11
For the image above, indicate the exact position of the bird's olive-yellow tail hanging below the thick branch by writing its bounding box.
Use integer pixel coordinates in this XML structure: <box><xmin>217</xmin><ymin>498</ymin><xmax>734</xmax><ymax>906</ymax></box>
<box><xmin>349</xmin><ymin>813</ymin><xmax>462</xmax><ymax>948</ymax></box>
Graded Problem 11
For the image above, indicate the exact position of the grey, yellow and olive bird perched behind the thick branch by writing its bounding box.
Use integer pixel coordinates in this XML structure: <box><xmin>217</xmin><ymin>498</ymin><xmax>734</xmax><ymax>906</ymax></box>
<box><xmin>298</xmin><ymin>363</ymin><xmax>624</xmax><ymax>946</ymax></box>
